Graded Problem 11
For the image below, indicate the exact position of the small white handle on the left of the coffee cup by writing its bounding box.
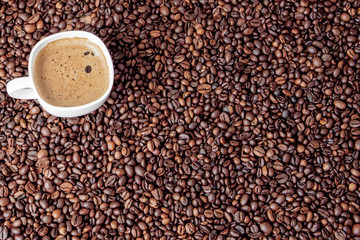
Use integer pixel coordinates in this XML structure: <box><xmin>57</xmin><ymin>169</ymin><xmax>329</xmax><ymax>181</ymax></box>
<box><xmin>6</xmin><ymin>77</ymin><xmax>36</xmax><ymax>99</ymax></box>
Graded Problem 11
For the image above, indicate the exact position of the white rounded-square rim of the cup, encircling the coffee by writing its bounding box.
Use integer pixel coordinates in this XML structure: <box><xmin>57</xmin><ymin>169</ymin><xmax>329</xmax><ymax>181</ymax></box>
<box><xmin>28</xmin><ymin>30</ymin><xmax>114</xmax><ymax>112</ymax></box>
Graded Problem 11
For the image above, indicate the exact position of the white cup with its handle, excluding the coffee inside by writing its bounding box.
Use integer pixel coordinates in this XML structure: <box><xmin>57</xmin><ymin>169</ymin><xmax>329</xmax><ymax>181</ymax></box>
<box><xmin>6</xmin><ymin>31</ymin><xmax>114</xmax><ymax>117</ymax></box>
